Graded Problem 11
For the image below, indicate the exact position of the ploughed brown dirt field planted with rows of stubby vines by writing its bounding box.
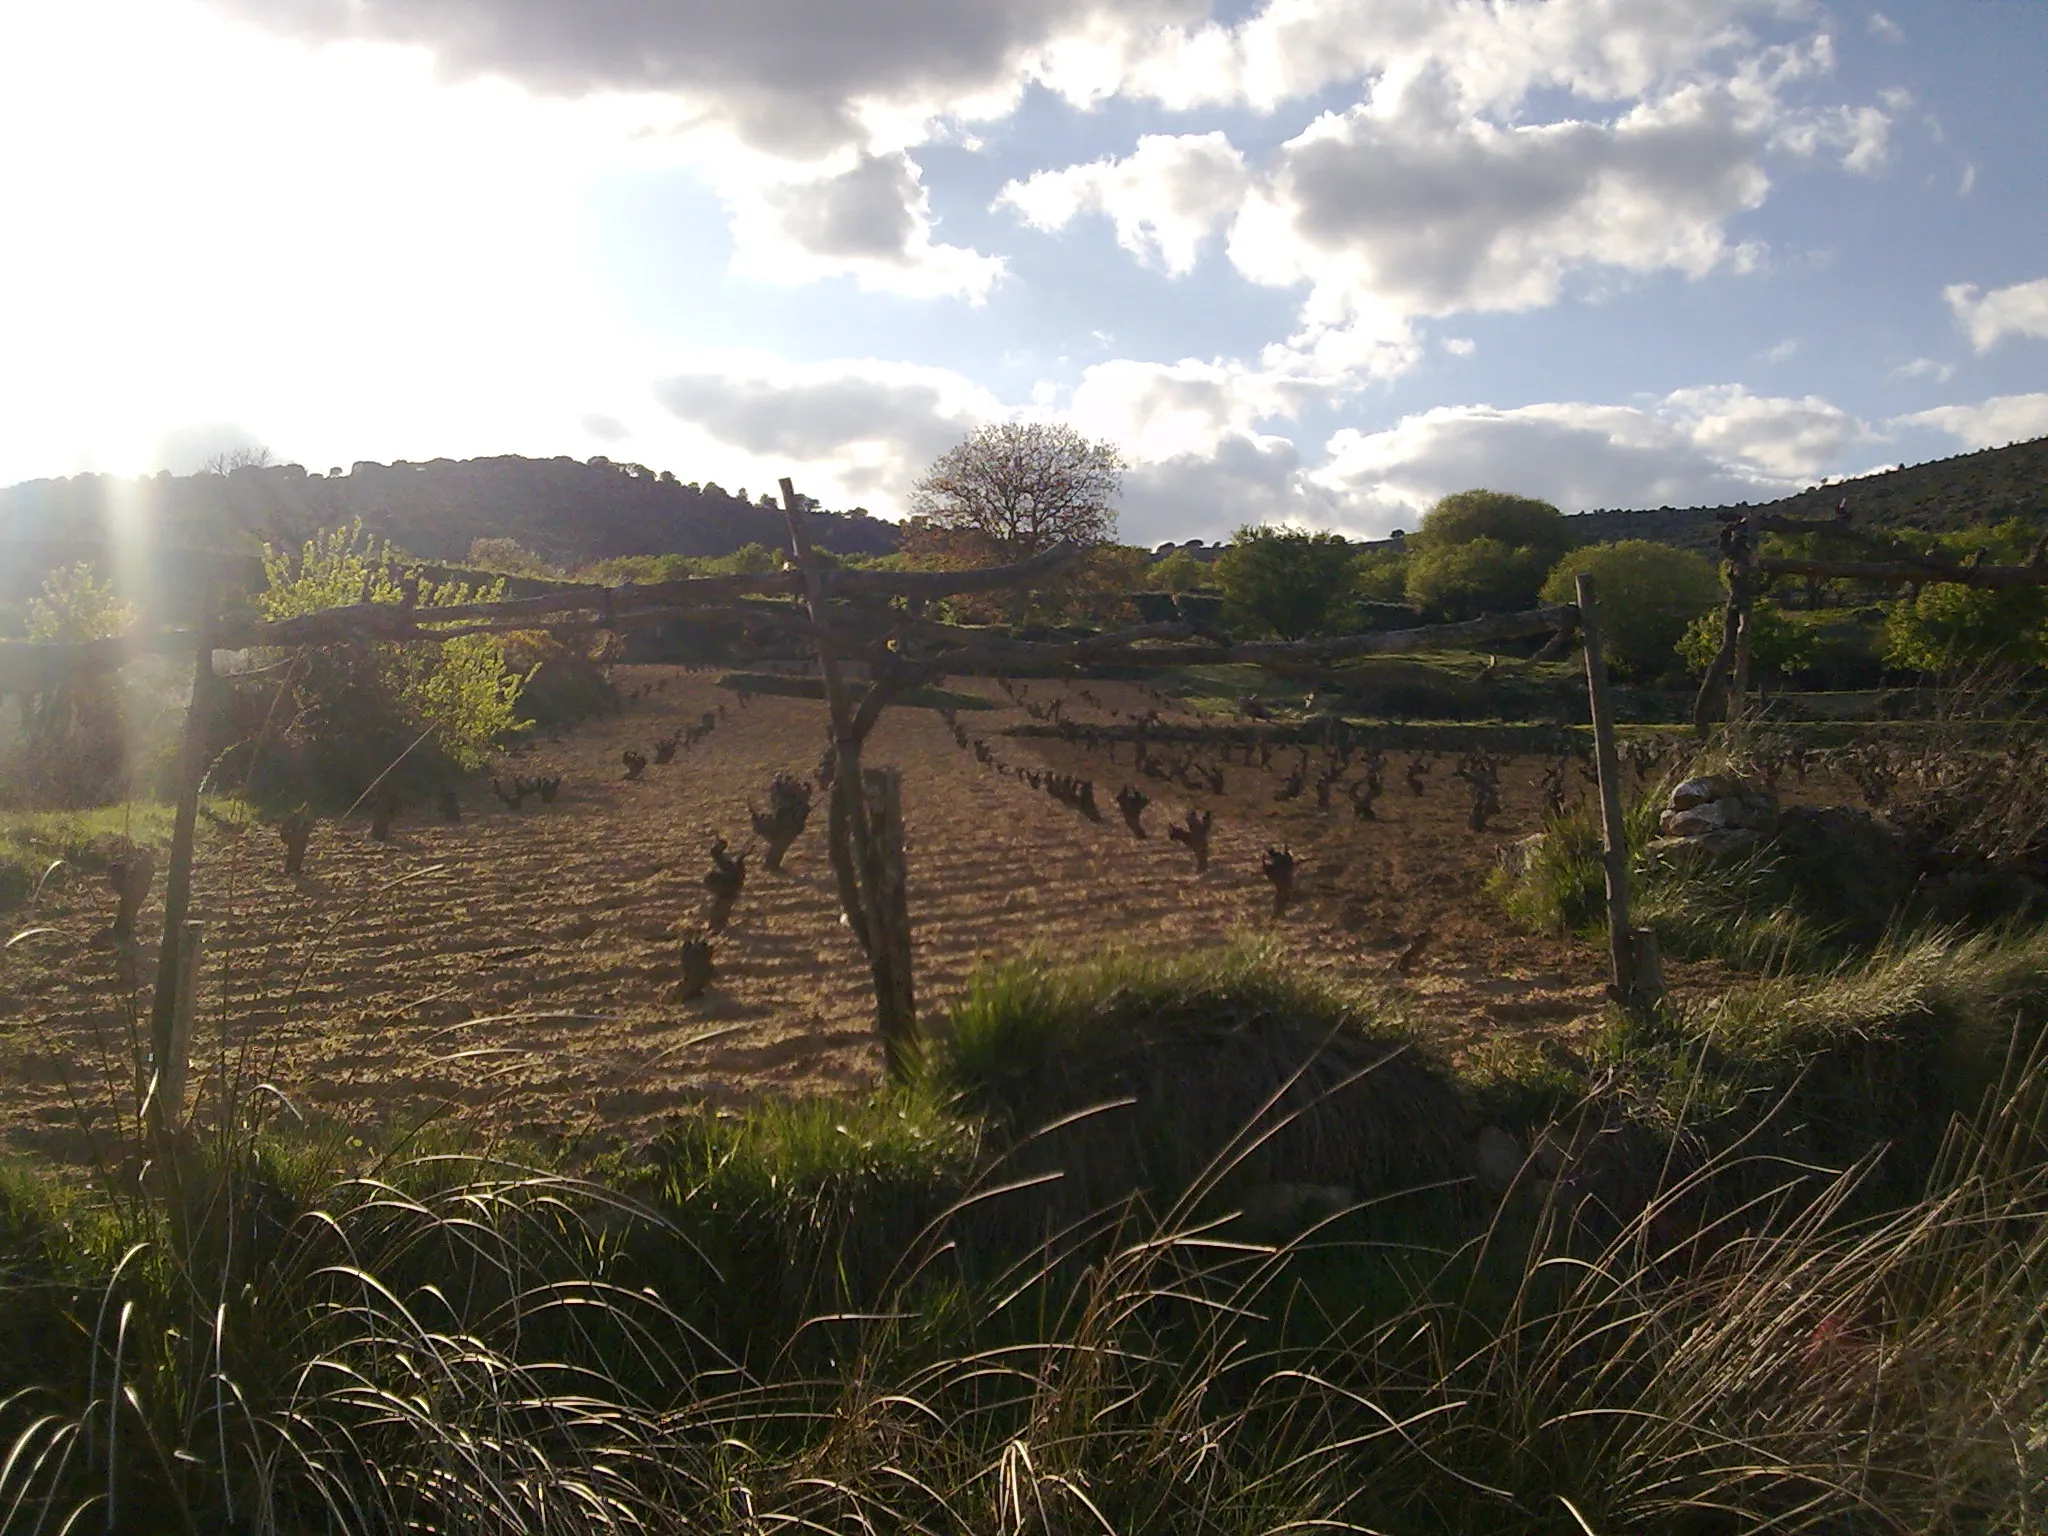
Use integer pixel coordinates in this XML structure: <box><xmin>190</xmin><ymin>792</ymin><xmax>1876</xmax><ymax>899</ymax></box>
<box><xmin>0</xmin><ymin>668</ymin><xmax>1736</xmax><ymax>1157</ymax></box>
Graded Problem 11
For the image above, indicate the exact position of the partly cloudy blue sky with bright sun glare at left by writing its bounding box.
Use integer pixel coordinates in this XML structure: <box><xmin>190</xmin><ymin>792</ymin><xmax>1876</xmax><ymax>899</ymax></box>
<box><xmin>0</xmin><ymin>0</ymin><xmax>2048</xmax><ymax>543</ymax></box>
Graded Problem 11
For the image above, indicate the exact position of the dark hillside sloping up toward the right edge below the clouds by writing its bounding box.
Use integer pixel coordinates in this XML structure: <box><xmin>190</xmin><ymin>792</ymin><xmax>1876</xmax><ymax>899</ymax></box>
<box><xmin>1573</xmin><ymin>438</ymin><xmax>2048</xmax><ymax>555</ymax></box>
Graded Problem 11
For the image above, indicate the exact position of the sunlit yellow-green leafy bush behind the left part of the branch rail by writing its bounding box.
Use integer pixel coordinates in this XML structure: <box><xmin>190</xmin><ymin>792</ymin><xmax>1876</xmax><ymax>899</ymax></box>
<box><xmin>256</xmin><ymin>522</ymin><xmax>524</xmax><ymax>799</ymax></box>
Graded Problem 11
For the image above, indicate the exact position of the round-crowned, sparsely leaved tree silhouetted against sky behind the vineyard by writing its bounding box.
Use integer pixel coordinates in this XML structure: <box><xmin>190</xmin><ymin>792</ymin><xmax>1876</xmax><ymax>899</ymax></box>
<box><xmin>911</xmin><ymin>422</ymin><xmax>1124</xmax><ymax>555</ymax></box>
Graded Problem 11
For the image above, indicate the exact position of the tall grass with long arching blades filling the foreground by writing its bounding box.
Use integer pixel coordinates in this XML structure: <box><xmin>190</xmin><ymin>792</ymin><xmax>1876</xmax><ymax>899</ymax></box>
<box><xmin>12</xmin><ymin>938</ymin><xmax>2048</xmax><ymax>1536</ymax></box>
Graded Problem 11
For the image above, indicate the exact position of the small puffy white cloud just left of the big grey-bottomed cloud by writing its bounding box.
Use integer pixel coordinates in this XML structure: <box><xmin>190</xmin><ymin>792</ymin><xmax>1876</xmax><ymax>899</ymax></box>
<box><xmin>995</xmin><ymin>133</ymin><xmax>1247</xmax><ymax>276</ymax></box>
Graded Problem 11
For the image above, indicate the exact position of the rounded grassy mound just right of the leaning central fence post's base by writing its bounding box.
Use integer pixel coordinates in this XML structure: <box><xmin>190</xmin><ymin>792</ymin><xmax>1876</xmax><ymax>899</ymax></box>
<box><xmin>928</xmin><ymin>944</ymin><xmax>1464</xmax><ymax>1206</ymax></box>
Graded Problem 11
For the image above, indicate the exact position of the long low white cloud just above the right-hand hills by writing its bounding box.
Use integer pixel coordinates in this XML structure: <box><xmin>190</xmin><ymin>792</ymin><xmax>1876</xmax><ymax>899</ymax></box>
<box><xmin>1309</xmin><ymin>385</ymin><xmax>1864</xmax><ymax>532</ymax></box>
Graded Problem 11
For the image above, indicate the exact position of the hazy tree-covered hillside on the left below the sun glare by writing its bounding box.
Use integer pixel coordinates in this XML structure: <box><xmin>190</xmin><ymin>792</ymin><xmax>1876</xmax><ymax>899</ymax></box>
<box><xmin>0</xmin><ymin>455</ymin><xmax>895</xmax><ymax>581</ymax></box>
